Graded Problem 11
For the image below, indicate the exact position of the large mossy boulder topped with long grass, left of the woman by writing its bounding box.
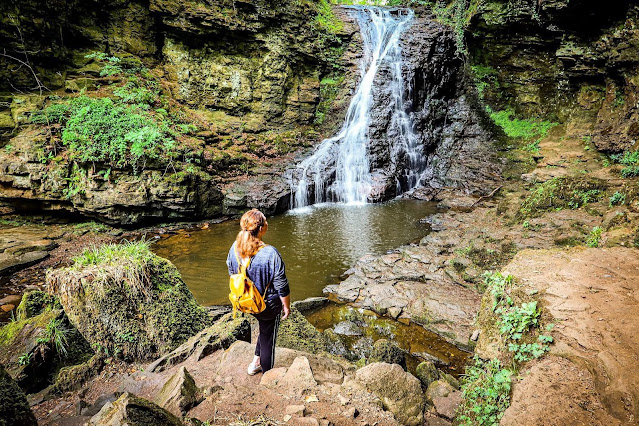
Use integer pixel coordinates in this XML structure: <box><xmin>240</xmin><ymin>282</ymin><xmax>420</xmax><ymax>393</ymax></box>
<box><xmin>47</xmin><ymin>242</ymin><xmax>210</xmax><ymax>360</ymax></box>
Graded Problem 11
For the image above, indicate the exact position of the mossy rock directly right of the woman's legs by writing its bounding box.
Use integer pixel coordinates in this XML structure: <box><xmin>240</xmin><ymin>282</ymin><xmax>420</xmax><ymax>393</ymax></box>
<box><xmin>276</xmin><ymin>307</ymin><xmax>326</xmax><ymax>354</ymax></box>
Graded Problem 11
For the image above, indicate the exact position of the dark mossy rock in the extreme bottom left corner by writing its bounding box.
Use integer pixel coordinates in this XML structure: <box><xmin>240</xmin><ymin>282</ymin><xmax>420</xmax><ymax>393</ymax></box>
<box><xmin>0</xmin><ymin>364</ymin><xmax>38</xmax><ymax>426</ymax></box>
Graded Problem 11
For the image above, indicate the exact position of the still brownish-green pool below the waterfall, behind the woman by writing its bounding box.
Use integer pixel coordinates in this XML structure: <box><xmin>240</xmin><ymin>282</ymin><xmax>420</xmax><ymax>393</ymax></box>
<box><xmin>153</xmin><ymin>200</ymin><xmax>437</xmax><ymax>306</ymax></box>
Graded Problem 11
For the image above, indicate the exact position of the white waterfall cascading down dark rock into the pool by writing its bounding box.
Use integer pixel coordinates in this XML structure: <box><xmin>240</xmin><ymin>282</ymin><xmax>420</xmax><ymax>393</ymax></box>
<box><xmin>291</xmin><ymin>7</ymin><xmax>425</xmax><ymax>208</ymax></box>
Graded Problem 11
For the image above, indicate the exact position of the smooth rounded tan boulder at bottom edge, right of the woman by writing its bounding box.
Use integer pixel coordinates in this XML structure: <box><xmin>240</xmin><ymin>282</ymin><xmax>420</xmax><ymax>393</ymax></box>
<box><xmin>355</xmin><ymin>362</ymin><xmax>425</xmax><ymax>425</ymax></box>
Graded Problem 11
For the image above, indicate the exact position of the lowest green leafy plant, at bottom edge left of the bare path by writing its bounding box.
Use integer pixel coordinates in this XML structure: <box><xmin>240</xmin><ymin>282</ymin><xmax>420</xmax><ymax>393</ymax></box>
<box><xmin>457</xmin><ymin>357</ymin><xmax>513</xmax><ymax>426</ymax></box>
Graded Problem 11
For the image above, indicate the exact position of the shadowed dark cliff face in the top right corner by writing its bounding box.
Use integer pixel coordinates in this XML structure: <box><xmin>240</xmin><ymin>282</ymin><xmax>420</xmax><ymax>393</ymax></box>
<box><xmin>468</xmin><ymin>0</ymin><xmax>639</xmax><ymax>152</ymax></box>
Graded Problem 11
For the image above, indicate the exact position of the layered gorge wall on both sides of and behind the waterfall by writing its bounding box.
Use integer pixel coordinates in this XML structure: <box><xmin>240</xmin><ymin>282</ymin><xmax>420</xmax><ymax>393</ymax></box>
<box><xmin>0</xmin><ymin>0</ymin><xmax>639</xmax><ymax>224</ymax></box>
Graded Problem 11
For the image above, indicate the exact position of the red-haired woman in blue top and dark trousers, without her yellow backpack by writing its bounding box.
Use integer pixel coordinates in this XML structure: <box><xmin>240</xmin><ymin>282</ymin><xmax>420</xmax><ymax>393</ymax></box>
<box><xmin>226</xmin><ymin>209</ymin><xmax>291</xmax><ymax>376</ymax></box>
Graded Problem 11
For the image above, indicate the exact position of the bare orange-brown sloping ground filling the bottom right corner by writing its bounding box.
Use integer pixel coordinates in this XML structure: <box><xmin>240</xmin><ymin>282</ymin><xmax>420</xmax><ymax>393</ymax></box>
<box><xmin>502</xmin><ymin>247</ymin><xmax>639</xmax><ymax>425</ymax></box>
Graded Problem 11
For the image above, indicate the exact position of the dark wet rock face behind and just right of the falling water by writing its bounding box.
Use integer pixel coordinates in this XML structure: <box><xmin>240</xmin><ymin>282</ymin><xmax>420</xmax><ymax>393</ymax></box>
<box><xmin>290</xmin><ymin>14</ymin><xmax>499</xmax><ymax>201</ymax></box>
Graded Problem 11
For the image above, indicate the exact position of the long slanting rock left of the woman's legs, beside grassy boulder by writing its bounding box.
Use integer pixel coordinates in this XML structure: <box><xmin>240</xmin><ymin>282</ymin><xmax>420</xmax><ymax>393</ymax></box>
<box><xmin>147</xmin><ymin>314</ymin><xmax>251</xmax><ymax>373</ymax></box>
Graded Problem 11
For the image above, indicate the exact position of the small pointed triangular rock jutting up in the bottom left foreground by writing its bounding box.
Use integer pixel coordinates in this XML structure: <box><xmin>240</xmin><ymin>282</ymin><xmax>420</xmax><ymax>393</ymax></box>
<box><xmin>153</xmin><ymin>367</ymin><xmax>203</xmax><ymax>416</ymax></box>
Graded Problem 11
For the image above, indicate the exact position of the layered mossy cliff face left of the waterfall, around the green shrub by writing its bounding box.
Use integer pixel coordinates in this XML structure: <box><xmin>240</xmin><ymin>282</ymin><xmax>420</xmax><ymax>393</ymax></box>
<box><xmin>0</xmin><ymin>0</ymin><xmax>354</xmax><ymax>224</ymax></box>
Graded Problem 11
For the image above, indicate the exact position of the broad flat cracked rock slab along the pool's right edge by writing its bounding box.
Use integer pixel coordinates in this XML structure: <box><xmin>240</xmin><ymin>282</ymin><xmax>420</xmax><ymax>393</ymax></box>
<box><xmin>324</xmin><ymin>248</ymin><xmax>481</xmax><ymax>348</ymax></box>
